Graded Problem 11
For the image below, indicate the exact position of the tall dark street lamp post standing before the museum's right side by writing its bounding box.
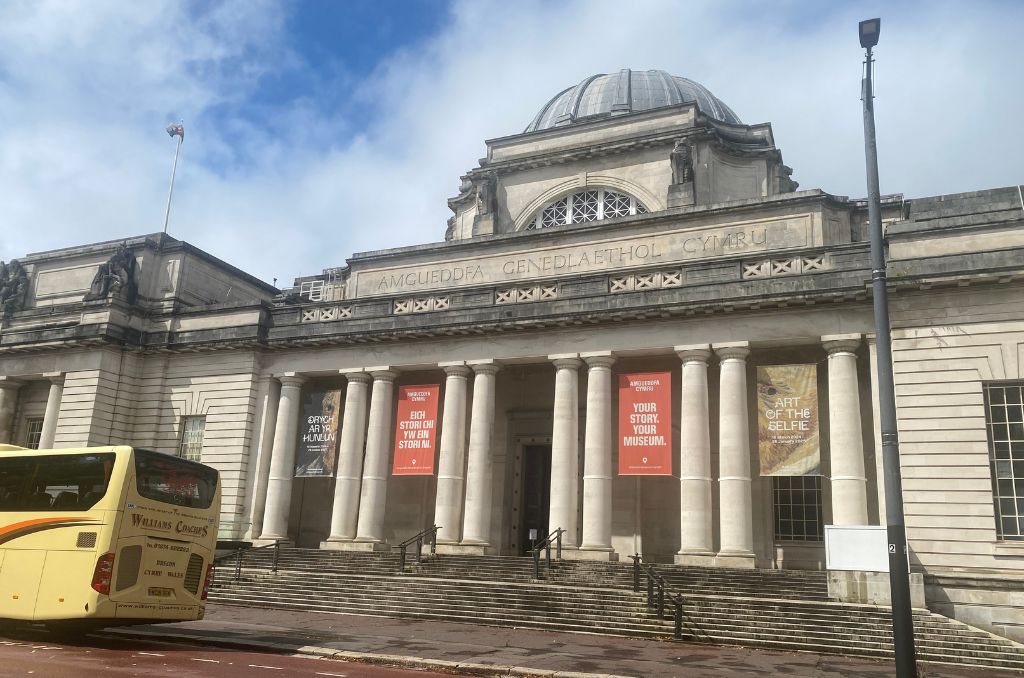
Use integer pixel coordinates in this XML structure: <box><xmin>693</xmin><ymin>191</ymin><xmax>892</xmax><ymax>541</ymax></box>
<box><xmin>860</xmin><ymin>18</ymin><xmax>918</xmax><ymax>678</ymax></box>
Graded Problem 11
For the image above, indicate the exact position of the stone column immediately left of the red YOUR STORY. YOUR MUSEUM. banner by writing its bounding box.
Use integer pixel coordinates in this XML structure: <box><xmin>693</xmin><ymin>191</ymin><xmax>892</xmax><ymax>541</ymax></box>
<box><xmin>580</xmin><ymin>351</ymin><xmax>615</xmax><ymax>556</ymax></box>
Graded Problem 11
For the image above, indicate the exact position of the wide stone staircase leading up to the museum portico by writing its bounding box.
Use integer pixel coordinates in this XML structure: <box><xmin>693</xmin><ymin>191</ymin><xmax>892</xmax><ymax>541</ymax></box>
<box><xmin>210</xmin><ymin>548</ymin><xmax>1024</xmax><ymax>673</ymax></box>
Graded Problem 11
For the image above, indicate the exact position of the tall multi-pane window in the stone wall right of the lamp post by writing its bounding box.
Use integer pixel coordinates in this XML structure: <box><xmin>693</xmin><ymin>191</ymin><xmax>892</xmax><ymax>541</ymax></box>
<box><xmin>985</xmin><ymin>382</ymin><xmax>1024</xmax><ymax>540</ymax></box>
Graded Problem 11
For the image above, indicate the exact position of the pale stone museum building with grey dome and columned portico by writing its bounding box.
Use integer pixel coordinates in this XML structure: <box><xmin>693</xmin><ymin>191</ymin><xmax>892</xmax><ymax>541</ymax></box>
<box><xmin>0</xmin><ymin>70</ymin><xmax>1024</xmax><ymax>639</ymax></box>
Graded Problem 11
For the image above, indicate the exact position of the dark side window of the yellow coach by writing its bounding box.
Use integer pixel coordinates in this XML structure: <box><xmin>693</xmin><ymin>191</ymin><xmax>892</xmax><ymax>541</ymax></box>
<box><xmin>0</xmin><ymin>453</ymin><xmax>114</xmax><ymax>512</ymax></box>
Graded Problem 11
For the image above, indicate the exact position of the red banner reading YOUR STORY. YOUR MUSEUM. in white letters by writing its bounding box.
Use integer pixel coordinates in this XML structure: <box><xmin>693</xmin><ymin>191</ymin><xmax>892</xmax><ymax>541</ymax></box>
<box><xmin>618</xmin><ymin>372</ymin><xmax>672</xmax><ymax>475</ymax></box>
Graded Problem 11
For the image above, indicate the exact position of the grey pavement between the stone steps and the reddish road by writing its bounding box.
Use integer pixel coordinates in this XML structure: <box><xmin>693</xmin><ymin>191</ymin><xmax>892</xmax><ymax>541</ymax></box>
<box><xmin>104</xmin><ymin>603</ymin><xmax>1021</xmax><ymax>678</ymax></box>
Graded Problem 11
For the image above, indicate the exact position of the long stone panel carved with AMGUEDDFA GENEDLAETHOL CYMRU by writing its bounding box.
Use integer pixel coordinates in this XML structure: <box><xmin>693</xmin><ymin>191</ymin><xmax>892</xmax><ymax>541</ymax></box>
<box><xmin>353</xmin><ymin>214</ymin><xmax>814</xmax><ymax>297</ymax></box>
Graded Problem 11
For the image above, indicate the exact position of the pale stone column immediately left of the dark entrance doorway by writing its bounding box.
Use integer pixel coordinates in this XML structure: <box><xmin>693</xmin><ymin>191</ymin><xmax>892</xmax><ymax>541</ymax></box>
<box><xmin>462</xmin><ymin>361</ymin><xmax>501</xmax><ymax>547</ymax></box>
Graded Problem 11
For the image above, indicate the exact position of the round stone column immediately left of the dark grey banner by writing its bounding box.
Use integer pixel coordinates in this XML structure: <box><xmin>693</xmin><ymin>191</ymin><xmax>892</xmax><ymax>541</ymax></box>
<box><xmin>259</xmin><ymin>372</ymin><xmax>305</xmax><ymax>541</ymax></box>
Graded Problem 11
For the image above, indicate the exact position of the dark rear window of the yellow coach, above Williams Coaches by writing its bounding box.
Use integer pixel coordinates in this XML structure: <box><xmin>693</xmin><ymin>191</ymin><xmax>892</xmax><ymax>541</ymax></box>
<box><xmin>135</xmin><ymin>450</ymin><xmax>217</xmax><ymax>508</ymax></box>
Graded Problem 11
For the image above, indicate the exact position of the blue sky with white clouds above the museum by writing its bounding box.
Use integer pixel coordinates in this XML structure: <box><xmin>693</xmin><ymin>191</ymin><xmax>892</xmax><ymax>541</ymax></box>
<box><xmin>0</xmin><ymin>0</ymin><xmax>1024</xmax><ymax>284</ymax></box>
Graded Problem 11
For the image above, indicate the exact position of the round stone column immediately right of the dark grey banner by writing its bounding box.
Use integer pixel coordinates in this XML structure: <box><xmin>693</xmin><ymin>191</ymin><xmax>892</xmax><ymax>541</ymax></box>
<box><xmin>322</xmin><ymin>371</ymin><xmax>373</xmax><ymax>548</ymax></box>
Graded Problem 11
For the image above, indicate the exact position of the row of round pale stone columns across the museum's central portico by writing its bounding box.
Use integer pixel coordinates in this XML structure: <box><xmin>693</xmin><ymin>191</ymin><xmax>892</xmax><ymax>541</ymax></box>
<box><xmin>261</xmin><ymin>335</ymin><xmax>867</xmax><ymax>566</ymax></box>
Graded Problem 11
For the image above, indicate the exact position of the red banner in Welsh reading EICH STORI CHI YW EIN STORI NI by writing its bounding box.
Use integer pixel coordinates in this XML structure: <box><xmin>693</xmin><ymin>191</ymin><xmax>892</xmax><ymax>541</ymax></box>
<box><xmin>391</xmin><ymin>384</ymin><xmax>440</xmax><ymax>475</ymax></box>
